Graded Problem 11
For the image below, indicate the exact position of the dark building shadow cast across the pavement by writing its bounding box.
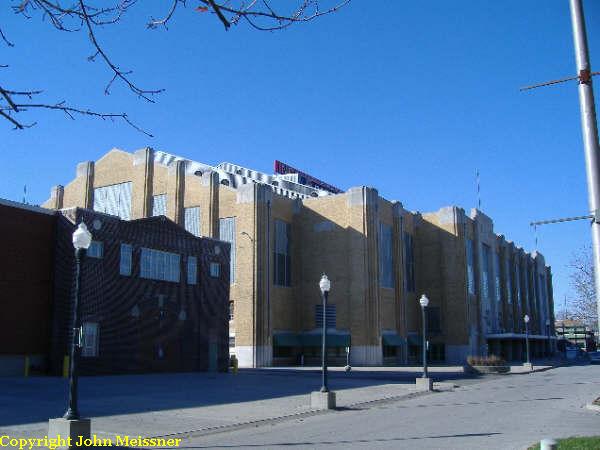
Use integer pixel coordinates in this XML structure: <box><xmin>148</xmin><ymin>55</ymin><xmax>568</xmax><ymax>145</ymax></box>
<box><xmin>0</xmin><ymin>369</ymin><xmax>473</xmax><ymax>428</ymax></box>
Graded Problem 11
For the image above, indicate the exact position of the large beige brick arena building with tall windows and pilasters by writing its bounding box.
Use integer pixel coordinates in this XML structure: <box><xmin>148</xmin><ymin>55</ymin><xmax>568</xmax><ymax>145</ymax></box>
<box><xmin>44</xmin><ymin>148</ymin><xmax>554</xmax><ymax>367</ymax></box>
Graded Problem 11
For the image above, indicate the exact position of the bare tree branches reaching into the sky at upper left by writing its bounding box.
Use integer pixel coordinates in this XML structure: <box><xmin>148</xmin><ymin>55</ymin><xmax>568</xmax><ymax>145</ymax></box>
<box><xmin>0</xmin><ymin>0</ymin><xmax>350</xmax><ymax>136</ymax></box>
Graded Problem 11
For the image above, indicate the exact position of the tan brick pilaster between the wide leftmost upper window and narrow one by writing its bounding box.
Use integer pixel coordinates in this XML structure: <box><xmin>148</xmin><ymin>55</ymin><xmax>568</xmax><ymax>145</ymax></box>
<box><xmin>132</xmin><ymin>147</ymin><xmax>154</xmax><ymax>219</ymax></box>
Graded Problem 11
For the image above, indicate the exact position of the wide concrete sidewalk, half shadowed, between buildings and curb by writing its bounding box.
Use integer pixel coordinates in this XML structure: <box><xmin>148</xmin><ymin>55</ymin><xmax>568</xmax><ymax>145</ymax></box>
<box><xmin>0</xmin><ymin>360</ymin><xmax>560</xmax><ymax>438</ymax></box>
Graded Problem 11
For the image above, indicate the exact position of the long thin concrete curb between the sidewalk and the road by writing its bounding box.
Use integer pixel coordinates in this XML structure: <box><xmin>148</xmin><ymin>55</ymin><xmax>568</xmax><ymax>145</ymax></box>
<box><xmin>151</xmin><ymin>390</ymin><xmax>436</xmax><ymax>439</ymax></box>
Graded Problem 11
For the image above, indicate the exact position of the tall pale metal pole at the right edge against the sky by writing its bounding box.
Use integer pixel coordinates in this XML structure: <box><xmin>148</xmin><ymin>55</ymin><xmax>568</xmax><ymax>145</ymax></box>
<box><xmin>569</xmin><ymin>0</ymin><xmax>600</xmax><ymax>331</ymax></box>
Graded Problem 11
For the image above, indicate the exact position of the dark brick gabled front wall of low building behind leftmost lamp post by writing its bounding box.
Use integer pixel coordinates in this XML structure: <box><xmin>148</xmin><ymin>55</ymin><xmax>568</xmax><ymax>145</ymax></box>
<box><xmin>52</xmin><ymin>209</ymin><xmax>230</xmax><ymax>374</ymax></box>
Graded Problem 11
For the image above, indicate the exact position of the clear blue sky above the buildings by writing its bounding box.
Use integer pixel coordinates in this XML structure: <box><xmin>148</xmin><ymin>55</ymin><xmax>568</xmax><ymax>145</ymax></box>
<box><xmin>0</xmin><ymin>0</ymin><xmax>600</xmax><ymax>307</ymax></box>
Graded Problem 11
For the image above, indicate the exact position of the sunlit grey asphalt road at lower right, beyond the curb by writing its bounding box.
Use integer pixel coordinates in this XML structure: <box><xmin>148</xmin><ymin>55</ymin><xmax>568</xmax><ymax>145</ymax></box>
<box><xmin>181</xmin><ymin>365</ymin><xmax>600</xmax><ymax>450</ymax></box>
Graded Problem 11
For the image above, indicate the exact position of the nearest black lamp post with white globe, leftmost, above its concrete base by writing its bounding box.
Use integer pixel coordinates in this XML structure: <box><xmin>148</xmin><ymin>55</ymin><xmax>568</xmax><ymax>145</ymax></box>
<box><xmin>63</xmin><ymin>222</ymin><xmax>92</xmax><ymax>420</ymax></box>
